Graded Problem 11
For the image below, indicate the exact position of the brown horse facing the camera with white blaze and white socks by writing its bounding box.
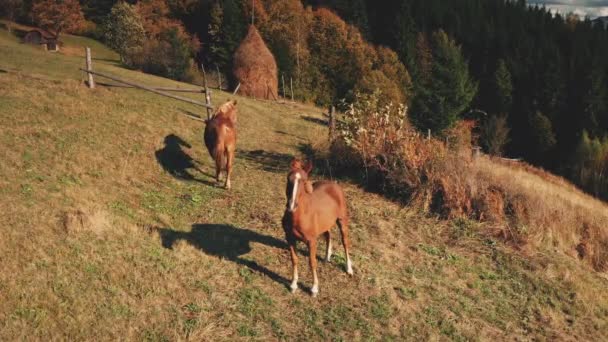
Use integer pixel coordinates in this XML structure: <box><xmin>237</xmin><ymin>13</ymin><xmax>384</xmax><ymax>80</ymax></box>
<box><xmin>283</xmin><ymin>159</ymin><xmax>353</xmax><ymax>297</ymax></box>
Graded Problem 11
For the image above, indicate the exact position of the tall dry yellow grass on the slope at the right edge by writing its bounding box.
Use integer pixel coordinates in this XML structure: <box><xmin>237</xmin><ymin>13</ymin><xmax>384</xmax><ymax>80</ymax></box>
<box><xmin>470</xmin><ymin>157</ymin><xmax>608</xmax><ymax>271</ymax></box>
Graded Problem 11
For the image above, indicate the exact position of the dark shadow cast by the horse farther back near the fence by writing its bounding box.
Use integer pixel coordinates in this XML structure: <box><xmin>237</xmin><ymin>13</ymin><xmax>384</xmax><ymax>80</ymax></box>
<box><xmin>154</xmin><ymin>134</ymin><xmax>215</xmax><ymax>186</ymax></box>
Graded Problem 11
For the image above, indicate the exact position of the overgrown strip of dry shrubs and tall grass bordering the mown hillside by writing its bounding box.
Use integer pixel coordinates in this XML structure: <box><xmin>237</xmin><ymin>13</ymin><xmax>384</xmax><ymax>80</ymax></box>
<box><xmin>330</xmin><ymin>93</ymin><xmax>608</xmax><ymax>271</ymax></box>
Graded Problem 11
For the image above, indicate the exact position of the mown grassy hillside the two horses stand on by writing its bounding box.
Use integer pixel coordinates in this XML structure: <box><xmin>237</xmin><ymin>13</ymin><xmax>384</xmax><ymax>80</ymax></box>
<box><xmin>0</xmin><ymin>24</ymin><xmax>608</xmax><ymax>341</ymax></box>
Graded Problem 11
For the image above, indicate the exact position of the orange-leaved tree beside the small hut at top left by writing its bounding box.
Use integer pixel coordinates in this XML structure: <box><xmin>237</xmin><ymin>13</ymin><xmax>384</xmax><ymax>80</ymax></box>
<box><xmin>32</xmin><ymin>0</ymin><xmax>85</xmax><ymax>38</ymax></box>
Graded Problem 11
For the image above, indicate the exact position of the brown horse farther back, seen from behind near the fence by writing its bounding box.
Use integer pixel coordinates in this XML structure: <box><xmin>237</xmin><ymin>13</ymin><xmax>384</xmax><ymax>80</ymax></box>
<box><xmin>205</xmin><ymin>100</ymin><xmax>237</xmax><ymax>189</ymax></box>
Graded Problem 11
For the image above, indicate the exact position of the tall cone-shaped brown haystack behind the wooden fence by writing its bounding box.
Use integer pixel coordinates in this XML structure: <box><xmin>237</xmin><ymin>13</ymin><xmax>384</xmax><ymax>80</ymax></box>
<box><xmin>233</xmin><ymin>25</ymin><xmax>279</xmax><ymax>100</ymax></box>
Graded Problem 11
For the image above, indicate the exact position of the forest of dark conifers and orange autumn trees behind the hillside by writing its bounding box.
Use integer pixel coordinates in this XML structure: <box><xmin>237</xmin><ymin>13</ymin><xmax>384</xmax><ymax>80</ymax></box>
<box><xmin>4</xmin><ymin>0</ymin><xmax>608</xmax><ymax>198</ymax></box>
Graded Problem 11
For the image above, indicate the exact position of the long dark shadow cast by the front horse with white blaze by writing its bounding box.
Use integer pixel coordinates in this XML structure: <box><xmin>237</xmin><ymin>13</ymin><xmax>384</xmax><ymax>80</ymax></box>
<box><xmin>155</xmin><ymin>224</ymin><xmax>289</xmax><ymax>287</ymax></box>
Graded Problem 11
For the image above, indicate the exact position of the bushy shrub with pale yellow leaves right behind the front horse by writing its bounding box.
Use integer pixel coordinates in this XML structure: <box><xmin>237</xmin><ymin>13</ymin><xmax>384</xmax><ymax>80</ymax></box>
<box><xmin>331</xmin><ymin>91</ymin><xmax>446</xmax><ymax>200</ymax></box>
